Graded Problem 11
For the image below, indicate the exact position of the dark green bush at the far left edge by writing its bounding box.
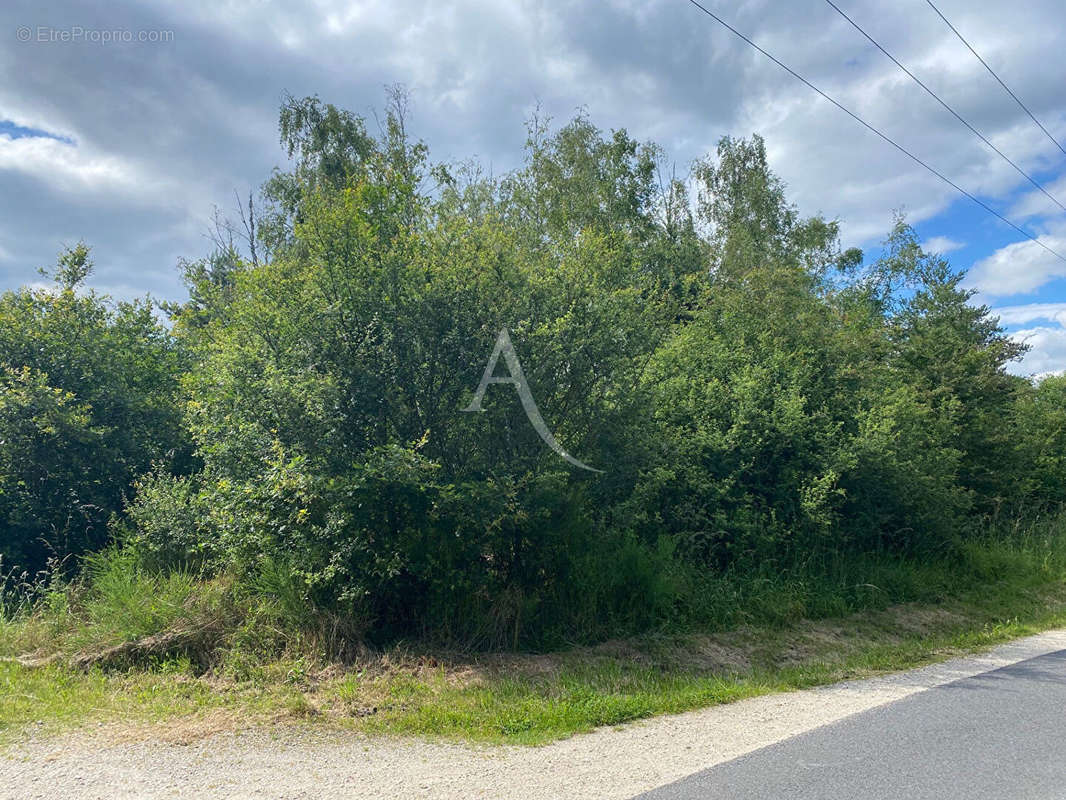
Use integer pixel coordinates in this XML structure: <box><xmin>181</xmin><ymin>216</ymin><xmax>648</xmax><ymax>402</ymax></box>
<box><xmin>0</xmin><ymin>244</ymin><xmax>188</xmax><ymax>573</ymax></box>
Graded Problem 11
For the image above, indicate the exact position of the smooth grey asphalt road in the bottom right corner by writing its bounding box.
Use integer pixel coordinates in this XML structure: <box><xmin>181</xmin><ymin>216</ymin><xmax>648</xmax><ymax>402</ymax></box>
<box><xmin>640</xmin><ymin>651</ymin><xmax>1066</xmax><ymax>800</ymax></box>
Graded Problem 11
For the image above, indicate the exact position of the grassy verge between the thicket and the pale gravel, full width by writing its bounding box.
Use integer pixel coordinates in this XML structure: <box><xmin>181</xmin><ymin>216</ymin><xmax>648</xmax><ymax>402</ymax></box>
<box><xmin>0</xmin><ymin>522</ymin><xmax>1066</xmax><ymax>745</ymax></box>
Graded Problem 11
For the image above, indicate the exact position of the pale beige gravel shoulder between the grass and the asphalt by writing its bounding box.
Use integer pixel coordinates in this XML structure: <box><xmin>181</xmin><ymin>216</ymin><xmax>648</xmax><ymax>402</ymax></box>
<box><xmin>6</xmin><ymin>630</ymin><xmax>1066</xmax><ymax>800</ymax></box>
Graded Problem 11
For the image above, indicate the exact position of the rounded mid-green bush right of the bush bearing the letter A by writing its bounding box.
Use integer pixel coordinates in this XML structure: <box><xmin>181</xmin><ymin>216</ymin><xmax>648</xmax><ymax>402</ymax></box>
<box><xmin>633</xmin><ymin>263</ymin><xmax>850</xmax><ymax>565</ymax></box>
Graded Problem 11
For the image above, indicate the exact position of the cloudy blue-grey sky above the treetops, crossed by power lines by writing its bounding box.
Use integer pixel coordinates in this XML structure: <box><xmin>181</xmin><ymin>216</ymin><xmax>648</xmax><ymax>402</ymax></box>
<box><xmin>0</xmin><ymin>0</ymin><xmax>1066</xmax><ymax>375</ymax></box>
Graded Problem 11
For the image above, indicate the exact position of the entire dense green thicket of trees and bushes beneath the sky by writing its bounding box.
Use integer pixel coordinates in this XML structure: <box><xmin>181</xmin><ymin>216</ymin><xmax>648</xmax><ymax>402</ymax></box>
<box><xmin>6</xmin><ymin>93</ymin><xmax>1066</xmax><ymax>646</ymax></box>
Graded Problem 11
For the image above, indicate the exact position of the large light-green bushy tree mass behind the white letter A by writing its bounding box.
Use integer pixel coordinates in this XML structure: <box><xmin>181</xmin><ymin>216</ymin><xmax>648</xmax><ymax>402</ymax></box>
<box><xmin>130</xmin><ymin>100</ymin><xmax>699</xmax><ymax>643</ymax></box>
